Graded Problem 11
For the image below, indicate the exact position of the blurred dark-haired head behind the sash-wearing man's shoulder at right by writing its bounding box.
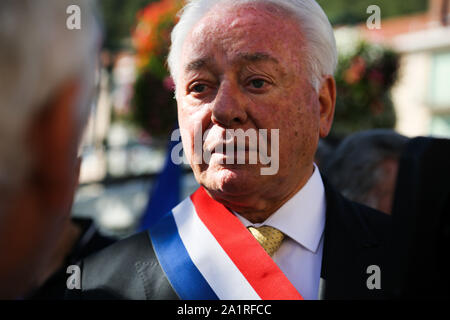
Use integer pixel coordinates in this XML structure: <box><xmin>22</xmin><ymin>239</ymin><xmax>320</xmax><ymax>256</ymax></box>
<box><xmin>324</xmin><ymin>129</ymin><xmax>408</xmax><ymax>214</ymax></box>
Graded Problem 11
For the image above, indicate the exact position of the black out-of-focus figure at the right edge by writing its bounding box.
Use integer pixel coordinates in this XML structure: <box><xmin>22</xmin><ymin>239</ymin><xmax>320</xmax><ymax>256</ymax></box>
<box><xmin>385</xmin><ymin>137</ymin><xmax>450</xmax><ymax>299</ymax></box>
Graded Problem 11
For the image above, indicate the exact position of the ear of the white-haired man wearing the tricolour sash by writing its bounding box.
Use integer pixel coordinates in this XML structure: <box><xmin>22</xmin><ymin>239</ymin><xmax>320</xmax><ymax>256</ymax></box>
<box><xmin>319</xmin><ymin>76</ymin><xmax>336</xmax><ymax>138</ymax></box>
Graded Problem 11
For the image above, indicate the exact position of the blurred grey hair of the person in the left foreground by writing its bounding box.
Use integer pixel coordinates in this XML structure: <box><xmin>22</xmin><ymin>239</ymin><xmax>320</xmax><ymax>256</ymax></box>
<box><xmin>0</xmin><ymin>0</ymin><xmax>101</xmax><ymax>211</ymax></box>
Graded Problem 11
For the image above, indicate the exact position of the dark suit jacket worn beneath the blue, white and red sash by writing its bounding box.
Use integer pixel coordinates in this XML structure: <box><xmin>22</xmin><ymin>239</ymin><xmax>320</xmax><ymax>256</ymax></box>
<box><xmin>66</xmin><ymin>179</ymin><xmax>391</xmax><ymax>300</ymax></box>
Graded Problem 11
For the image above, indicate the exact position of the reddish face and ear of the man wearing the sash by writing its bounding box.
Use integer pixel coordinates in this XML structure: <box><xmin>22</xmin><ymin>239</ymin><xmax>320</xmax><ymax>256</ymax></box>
<box><xmin>176</xmin><ymin>4</ymin><xmax>335</xmax><ymax>222</ymax></box>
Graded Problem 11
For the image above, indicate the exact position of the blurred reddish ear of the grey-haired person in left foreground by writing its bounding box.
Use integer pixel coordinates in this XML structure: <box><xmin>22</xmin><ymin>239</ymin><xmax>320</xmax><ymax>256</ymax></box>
<box><xmin>27</xmin><ymin>81</ymin><xmax>79</xmax><ymax>209</ymax></box>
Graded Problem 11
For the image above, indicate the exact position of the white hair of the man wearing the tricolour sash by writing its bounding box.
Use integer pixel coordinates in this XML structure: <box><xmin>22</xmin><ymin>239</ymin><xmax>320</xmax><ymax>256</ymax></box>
<box><xmin>168</xmin><ymin>0</ymin><xmax>337</xmax><ymax>91</ymax></box>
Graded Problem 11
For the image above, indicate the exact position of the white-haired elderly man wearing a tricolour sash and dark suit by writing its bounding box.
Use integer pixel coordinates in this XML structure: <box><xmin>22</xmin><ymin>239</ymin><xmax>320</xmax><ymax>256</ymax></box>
<box><xmin>74</xmin><ymin>0</ymin><xmax>389</xmax><ymax>299</ymax></box>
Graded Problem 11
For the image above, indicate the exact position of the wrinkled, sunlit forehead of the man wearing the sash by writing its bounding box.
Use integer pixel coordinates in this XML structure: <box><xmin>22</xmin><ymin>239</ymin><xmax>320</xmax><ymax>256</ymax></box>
<box><xmin>181</xmin><ymin>2</ymin><xmax>304</xmax><ymax>70</ymax></box>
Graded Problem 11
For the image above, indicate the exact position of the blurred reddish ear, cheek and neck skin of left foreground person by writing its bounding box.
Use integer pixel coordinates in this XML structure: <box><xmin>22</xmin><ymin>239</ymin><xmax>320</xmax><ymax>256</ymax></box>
<box><xmin>0</xmin><ymin>80</ymin><xmax>81</xmax><ymax>299</ymax></box>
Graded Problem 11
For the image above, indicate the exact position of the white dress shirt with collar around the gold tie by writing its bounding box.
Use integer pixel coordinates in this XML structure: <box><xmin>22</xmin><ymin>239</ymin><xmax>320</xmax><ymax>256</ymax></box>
<box><xmin>234</xmin><ymin>164</ymin><xmax>326</xmax><ymax>300</ymax></box>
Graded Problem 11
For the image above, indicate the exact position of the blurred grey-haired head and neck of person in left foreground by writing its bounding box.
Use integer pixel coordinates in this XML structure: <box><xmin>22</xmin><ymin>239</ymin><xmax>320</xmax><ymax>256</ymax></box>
<box><xmin>0</xmin><ymin>0</ymin><xmax>101</xmax><ymax>298</ymax></box>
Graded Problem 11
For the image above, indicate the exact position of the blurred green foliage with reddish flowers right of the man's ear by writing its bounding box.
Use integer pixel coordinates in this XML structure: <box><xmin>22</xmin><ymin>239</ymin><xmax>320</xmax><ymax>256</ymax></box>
<box><xmin>331</xmin><ymin>42</ymin><xmax>399</xmax><ymax>139</ymax></box>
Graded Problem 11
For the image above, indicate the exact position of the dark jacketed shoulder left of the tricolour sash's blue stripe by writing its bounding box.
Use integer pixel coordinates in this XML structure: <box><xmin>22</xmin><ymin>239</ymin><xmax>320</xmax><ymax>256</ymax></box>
<box><xmin>68</xmin><ymin>232</ymin><xmax>176</xmax><ymax>300</ymax></box>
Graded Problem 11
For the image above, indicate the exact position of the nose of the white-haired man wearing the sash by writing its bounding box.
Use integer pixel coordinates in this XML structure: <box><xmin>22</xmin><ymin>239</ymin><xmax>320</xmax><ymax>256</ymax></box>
<box><xmin>211</xmin><ymin>81</ymin><xmax>247</xmax><ymax>128</ymax></box>
